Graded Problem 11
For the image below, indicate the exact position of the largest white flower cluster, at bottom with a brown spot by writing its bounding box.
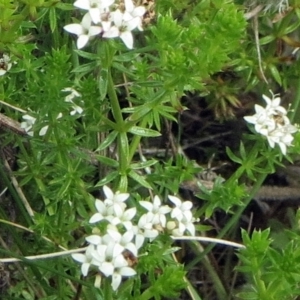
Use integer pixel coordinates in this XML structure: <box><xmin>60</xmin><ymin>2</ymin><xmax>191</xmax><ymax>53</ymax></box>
<box><xmin>72</xmin><ymin>186</ymin><xmax>195</xmax><ymax>290</ymax></box>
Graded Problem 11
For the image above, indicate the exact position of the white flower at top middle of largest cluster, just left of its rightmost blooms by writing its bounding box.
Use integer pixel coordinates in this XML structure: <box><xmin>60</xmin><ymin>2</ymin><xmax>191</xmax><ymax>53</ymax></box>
<box><xmin>139</xmin><ymin>196</ymin><xmax>171</xmax><ymax>227</ymax></box>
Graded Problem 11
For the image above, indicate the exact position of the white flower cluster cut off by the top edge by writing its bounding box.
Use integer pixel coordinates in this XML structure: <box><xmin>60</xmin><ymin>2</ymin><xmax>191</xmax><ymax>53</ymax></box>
<box><xmin>64</xmin><ymin>0</ymin><xmax>146</xmax><ymax>49</ymax></box>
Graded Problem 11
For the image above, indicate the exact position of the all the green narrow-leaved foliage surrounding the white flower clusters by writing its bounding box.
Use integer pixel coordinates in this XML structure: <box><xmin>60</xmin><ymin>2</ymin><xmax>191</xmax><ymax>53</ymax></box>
<box><xmin>0</xmin><ymin>0</ymin><xmax>300</xmax><ymax>300</ymax></box>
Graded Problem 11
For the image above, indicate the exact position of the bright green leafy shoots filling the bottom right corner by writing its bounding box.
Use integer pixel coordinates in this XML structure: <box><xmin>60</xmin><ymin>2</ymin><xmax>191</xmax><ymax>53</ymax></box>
<box><xmin>237</xmin><ymin>230</ymin><xmax>300</xmax><ymax>300</ymax></box>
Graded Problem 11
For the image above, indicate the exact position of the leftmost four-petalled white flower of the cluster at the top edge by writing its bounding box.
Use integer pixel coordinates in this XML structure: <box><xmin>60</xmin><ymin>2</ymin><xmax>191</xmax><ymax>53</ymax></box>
<box><xmin>64</xmin><ymin>13</ymin><xmax>102</xmax><ymax>49</ymax></box>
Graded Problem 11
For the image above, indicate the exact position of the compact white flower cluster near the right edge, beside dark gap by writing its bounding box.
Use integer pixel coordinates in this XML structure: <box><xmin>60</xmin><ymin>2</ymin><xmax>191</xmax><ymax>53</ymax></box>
<box><xmin>244</xmin><ymin>94</ymin><xmax>298</xmax><ymax>154</ymax></box>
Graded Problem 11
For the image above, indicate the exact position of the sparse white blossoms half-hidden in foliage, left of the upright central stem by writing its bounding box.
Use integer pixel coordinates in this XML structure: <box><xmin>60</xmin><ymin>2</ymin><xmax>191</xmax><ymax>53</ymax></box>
<box><xmin>21</xmin><ymin>87</ymin><xmax>83</xmax><ymax>136</ymax></box>
